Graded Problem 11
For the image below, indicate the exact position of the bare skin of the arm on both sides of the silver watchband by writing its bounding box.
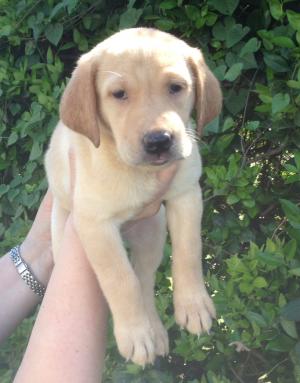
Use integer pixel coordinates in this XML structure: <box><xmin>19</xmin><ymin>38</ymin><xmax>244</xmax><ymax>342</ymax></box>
<box><xmin>0</xmin><ymin>192</ymin><xmax>53</xmax><ymax>343</ymax></box>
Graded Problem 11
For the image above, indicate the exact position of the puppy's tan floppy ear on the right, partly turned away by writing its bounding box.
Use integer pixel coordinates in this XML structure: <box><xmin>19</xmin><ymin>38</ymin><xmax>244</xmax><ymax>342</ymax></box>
<box><xmin>190</xmin><ymin>48</ymin><xmax>222</xmax><ymax>134</ymax></box>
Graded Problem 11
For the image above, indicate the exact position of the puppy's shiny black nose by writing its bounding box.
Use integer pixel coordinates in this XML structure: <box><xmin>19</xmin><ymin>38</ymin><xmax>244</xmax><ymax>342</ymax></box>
<box><xmin>143</xmin><ymin>130</ymin><xmax>173</xmax><ymax>154</ymax></box>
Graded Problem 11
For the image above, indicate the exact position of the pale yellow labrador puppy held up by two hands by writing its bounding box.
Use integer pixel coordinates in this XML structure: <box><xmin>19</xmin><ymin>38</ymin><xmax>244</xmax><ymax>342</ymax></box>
<box><xmin>46</xmin><ymin>28</ymin><xmax>221</xmax><ymax>365</ymax></box>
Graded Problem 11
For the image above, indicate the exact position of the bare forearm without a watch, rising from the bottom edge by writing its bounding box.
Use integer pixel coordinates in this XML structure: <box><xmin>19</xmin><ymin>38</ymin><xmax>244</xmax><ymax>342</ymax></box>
<box><xmin>15</xmin><ymin>219</ymin><xmax>107</xmax><ymax>383</ymax></box>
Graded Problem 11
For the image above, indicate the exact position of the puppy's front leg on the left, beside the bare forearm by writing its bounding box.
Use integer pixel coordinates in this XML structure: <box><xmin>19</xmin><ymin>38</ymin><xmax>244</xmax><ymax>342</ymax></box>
<box><xmin>75</xmin><ymin>215</ymin><xmax>155</xmax><ymax>366</ymax></box>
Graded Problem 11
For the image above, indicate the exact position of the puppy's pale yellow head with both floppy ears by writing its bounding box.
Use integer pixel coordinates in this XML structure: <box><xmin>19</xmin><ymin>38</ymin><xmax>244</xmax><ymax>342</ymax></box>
<box><xmin>60</xmin><ymin>28</ymin><xmax>222</xmax><ymax>166</ymax></box>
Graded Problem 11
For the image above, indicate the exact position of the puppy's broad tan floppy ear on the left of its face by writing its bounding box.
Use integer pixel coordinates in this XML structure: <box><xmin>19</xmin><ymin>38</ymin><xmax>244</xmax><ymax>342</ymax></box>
<box><xmin>60</xmin><ymin>56</ymin><xmax>100</xmax><ymax>148</ymax></box>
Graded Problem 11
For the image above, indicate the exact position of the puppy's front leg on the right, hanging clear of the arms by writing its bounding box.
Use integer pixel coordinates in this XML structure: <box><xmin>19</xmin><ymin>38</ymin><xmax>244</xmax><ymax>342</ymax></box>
<box><xmin>167</xmin><ymin>185</ymin><xmax>216</xmax><ymax>334</ymax></box>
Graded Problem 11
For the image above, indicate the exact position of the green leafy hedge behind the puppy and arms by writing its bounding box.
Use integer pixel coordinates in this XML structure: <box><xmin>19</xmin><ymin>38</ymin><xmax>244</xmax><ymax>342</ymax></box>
<box><xmin>0</xmin><ymin>0</ymin><xmax>300</xmax><ymax>383</ymax></box>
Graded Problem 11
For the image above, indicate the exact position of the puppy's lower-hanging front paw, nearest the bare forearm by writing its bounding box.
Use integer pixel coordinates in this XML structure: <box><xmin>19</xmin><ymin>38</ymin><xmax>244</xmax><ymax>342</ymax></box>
<box><xmin>114</xmin><ymin>320</ymin><xmax>155</xmax><ymax>367</ymax></box>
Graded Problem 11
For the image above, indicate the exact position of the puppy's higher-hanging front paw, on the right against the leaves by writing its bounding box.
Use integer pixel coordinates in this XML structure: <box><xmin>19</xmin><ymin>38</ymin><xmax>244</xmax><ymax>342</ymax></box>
<box><xmin>174</xmin><ymin>287</ymin><xmax>216</xmax><ymax>335</ymax></box>
